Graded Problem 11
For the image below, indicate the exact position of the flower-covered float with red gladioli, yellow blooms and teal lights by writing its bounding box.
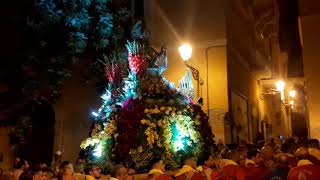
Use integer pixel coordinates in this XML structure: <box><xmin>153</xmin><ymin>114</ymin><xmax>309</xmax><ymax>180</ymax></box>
<box><xmin>81</xmin><ymin>41</ymin><xmax>214</xmax><ymax>172</ymax></box>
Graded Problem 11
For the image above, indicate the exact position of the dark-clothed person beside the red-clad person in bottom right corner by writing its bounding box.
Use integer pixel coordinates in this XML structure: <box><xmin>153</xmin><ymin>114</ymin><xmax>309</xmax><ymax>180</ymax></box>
<box><xmin>262</xmin><ymin>153</ymin><xmax>290</xmax><ymax>180</ymax></box>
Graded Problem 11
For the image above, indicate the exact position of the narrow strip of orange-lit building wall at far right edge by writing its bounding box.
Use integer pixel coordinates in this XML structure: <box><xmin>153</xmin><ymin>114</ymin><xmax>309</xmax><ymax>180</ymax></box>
<box><xmin>300</xmin><ymin>14</ymin><xmax>320</xmax><ymax>139</ymax></box>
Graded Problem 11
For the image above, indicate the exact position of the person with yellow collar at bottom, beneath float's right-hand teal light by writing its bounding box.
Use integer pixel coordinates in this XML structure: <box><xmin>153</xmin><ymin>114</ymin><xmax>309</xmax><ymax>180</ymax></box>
<box><xmin>175</xmin><ymin>154</ymin><xmax>206</xmax><ymax>180</ymax></box>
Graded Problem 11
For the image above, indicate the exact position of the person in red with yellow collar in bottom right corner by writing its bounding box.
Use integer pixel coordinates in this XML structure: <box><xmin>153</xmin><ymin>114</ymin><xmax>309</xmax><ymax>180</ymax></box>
<box><xmin>287</xmin><ymin>147</ymin><xmax>320</xmax><ymax>180</ymax></box>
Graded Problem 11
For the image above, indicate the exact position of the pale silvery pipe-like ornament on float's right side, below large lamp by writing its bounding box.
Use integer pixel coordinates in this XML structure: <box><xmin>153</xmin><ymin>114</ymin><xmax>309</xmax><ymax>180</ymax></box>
<box><xmin>179</xmin><ymin>67</ymin><xmax>194</xmax><ymax>99</ymax></box>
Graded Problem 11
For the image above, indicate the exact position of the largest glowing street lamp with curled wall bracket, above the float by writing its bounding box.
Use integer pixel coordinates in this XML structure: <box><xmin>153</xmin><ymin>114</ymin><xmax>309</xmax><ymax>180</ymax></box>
<box><xmin>179</xmin><ymin>43</ymin><xmax>203</xmax><ymax>98</ymax></box>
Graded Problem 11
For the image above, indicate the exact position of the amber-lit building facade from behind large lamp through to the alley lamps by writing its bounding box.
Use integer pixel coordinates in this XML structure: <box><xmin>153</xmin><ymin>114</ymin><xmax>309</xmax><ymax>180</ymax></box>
<box><xmin>144</xmin><ymin>0</ymin><xmax>307</xmax><ymax>143</ymax></box>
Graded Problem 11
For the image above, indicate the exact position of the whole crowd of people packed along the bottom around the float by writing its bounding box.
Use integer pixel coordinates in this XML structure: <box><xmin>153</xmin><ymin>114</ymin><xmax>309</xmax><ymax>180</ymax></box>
<box><xmin>0</xmin><ymin>138</ymin><xmax>320</xmax><ymax>180</ymax></box>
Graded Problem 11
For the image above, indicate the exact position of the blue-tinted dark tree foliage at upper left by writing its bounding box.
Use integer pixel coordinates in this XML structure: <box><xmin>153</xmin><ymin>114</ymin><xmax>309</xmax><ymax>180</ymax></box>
<box><xmin>25</xmin><ymin>0</ymin><xmax>130</xmax><ymax>101</ymax></box>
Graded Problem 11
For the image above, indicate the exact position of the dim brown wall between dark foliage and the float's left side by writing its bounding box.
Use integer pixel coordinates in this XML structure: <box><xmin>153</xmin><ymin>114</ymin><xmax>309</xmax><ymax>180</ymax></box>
<box><xmin>54</xmin><ymin>63</ymin><xmax>99</xmax><ymax>162</ymax></box>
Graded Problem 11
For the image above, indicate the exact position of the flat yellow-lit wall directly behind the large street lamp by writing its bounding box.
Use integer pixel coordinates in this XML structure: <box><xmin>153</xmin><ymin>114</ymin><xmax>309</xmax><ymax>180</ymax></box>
<box><xmin>145</xmin><ymin>0</ymin><xmax>228</xmax><ymax>140</ymax></box>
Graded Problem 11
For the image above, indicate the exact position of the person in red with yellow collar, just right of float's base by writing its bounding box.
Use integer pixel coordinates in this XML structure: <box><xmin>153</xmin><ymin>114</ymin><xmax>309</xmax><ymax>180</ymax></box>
<box><xmin>221</xmin><ymin>150</ymin><xmax>245</xmax><ymax>180</ymax></box>
